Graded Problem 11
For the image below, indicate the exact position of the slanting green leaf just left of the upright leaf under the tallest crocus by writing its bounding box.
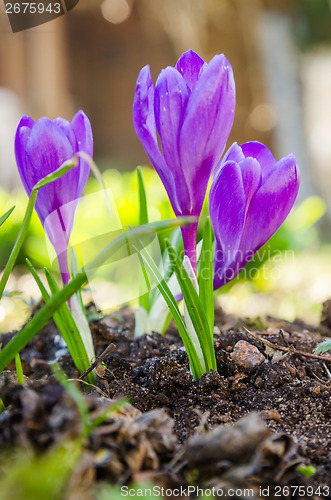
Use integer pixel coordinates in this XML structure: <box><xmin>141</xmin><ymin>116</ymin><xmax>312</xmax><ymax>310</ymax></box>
<box><xmin>165</xmin><ymin>240</ymin><xmax>217</xmax><ymax>371</ymax></box>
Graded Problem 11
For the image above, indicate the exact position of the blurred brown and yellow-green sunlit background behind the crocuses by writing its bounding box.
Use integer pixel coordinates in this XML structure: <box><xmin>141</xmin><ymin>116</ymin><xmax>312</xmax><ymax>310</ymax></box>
<box><xmin>0</xmin><ymin>0</ymin><xmax>331</xmax><ymax>331</ymax></box>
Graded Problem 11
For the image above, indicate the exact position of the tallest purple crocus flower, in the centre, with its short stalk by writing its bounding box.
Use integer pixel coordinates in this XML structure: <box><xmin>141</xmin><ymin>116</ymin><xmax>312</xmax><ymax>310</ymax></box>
<box><xmin>133</xmin><ymin>50</ymin><xmax>235</xmax><ymax>269</ymax></box>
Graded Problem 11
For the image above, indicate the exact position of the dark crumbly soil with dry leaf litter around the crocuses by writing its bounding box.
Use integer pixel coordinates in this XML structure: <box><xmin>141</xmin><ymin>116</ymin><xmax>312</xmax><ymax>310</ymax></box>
<box><xmin>0</xmin><ymin>304</ymin><xmax>331</xmax><ymax>498</ymax></box>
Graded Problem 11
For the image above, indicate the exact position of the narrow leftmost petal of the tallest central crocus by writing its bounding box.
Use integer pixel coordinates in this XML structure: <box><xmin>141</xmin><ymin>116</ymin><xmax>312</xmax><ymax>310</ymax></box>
<box><xmin>132</xmin><ymin>66</ymin><xmax>179</xmax><ymax>213</ymax></box>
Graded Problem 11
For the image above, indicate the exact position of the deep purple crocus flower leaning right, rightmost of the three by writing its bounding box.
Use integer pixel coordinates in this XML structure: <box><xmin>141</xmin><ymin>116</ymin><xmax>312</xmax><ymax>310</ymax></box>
<box><xmin>209</xmin><ymin>142</ymin><xmax>299</xmax><ymax>289</ymax></box>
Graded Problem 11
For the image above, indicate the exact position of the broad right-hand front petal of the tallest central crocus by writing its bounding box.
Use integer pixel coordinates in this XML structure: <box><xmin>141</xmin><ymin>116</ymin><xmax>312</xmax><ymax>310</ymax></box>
<box><xmin>179</xmin><ymin>54</ymin><xmax>235</xmax><ymax>215</ymax></box>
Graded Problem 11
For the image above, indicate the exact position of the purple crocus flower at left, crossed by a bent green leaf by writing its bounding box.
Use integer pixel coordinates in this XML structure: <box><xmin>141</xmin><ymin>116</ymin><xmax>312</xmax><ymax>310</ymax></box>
<box><xmin>15</xmin><ymin>111</ymin><xmax>93</xmax><ymax>284</ymax></box>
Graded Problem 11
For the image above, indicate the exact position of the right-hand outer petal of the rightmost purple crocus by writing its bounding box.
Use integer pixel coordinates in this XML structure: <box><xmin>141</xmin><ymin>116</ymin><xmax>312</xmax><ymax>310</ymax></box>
<box><xmin>241</xmin><ymin>154</ymin><xmax>299</xmax><ymax>256</ymax></box>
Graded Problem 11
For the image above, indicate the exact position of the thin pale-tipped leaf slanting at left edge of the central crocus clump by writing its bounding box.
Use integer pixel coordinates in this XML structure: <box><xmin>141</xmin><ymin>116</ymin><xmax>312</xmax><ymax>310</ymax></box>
<box><xmin>136</xmin><ymin>245</ymin><xmax>204</xmax><ymax>380</ymax></box>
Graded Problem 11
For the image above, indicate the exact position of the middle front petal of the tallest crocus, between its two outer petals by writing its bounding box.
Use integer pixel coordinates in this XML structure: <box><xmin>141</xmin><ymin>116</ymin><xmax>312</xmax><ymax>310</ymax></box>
<box><xmin>154</xmin><ymin>67</ymin><xmax>193</xmax><ymax>214</ymax></box>
